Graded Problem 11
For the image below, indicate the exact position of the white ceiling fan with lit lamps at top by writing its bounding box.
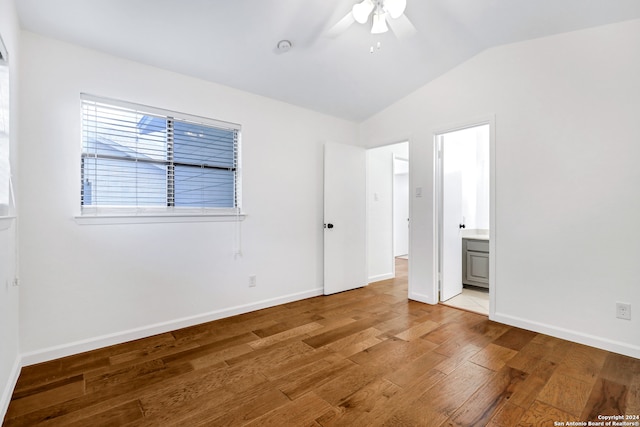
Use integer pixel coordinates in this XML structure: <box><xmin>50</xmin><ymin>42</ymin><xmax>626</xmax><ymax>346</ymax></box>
<box><xmin>328</xmin><ymin>0</ymin><xmax>416</xmax><ymax>38</ymax></box>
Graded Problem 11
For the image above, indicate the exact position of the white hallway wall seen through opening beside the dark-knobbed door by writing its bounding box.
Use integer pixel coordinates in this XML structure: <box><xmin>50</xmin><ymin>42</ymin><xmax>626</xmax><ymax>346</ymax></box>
<box><xmin>367</xmin><ymin>142</ymin><xmax>409</xmax><ymax>282</ymax></box>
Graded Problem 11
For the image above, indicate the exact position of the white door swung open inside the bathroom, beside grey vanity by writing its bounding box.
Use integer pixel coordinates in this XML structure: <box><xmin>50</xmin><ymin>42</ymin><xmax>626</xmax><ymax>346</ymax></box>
<box><xmin>439</xmin><ymin>135</ymin><xmax>464</xmax><ymax>301</ymax></box>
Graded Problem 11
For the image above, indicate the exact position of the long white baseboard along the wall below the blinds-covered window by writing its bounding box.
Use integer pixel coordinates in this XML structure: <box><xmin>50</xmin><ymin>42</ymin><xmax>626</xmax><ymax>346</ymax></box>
<box><xmin>21</xmin><ymin>288</ymin><xmax>323</xmax><ymax>370</ymax></box>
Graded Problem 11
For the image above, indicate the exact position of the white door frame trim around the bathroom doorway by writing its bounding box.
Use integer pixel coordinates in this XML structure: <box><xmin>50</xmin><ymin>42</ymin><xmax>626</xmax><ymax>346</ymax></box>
<box><xmin>432</xmin><ymin>114</ymin><xmax>497</xmax><ymax>319</ymax></box>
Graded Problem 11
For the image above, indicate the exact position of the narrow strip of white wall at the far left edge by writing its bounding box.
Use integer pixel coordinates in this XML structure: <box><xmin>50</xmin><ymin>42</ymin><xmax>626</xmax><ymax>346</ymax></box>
<box><xmin>0</xmin><ymin>0</ymin><xmax>20</xmax><ymax>419</ymax></box>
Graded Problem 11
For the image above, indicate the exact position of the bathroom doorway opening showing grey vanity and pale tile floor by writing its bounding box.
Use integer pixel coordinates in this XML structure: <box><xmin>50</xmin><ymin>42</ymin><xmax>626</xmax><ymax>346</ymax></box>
<box><xmin>434</xmin><ymin>123</ymin><xmax>492</xmax><ymax>315</ymax></box>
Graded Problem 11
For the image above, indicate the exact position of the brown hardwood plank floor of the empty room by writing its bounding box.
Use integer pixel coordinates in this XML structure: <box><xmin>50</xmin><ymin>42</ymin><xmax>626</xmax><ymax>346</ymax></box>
<box><xmin>3</xmin><ymin>260</ymin><xmax>640</xmax><ymax>427</ymax></box>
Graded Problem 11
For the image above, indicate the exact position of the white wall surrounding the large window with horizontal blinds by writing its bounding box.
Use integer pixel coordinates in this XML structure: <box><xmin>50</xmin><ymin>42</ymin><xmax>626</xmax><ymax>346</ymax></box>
<box><xmin>20</xmin><ymin>32</ymin><xmax>357</xmax><ymax>363</ymax></box>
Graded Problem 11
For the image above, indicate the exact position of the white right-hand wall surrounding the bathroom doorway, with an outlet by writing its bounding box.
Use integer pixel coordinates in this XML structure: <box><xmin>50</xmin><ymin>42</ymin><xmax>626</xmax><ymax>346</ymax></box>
<box><xmin>360</xmin><ymin>20</ymin><xmax>640</xmax><ymax>357</ymax></box>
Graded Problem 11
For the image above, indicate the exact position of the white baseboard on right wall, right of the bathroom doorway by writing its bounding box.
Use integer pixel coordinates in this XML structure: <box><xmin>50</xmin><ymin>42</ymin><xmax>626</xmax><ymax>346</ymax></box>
<box><xmin>491</xmin><ymin>313</ymin><xmax>640</xmax><ymax>359</ymax></box>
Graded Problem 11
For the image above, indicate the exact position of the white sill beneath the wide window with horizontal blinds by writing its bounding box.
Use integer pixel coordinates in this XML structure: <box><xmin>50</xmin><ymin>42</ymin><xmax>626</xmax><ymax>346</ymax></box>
<box><xmin>74</xmin><ymin>213</ymin><xmax>247</xmax><ymax>225</ymax></box>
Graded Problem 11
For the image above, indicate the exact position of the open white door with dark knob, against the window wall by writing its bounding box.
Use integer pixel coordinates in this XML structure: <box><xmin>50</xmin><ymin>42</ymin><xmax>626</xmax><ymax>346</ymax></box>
<box><xmin>324</xmin><ymin>143</ymin><xmax>367</xmax><ymax>295</ymax></box>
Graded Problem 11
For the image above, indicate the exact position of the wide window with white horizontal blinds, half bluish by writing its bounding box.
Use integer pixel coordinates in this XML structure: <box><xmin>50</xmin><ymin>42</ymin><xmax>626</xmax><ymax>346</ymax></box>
<box><xmin>80</xmin><ymin>95</ymin><xmax>240</xmax><ymax>215</ymax></box>
